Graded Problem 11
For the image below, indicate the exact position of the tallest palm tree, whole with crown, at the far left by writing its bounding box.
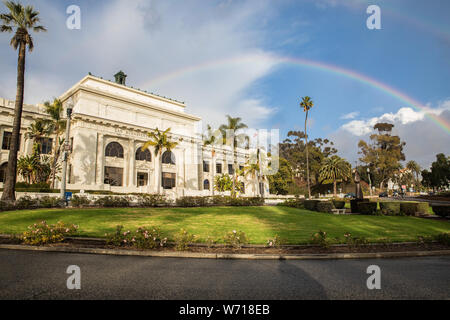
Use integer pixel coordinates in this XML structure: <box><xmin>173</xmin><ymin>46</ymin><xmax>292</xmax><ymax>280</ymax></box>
<box><xmin>0</xmin><ymin>1</ymin><xmax>46</xmax><ymax>201</ymax></box>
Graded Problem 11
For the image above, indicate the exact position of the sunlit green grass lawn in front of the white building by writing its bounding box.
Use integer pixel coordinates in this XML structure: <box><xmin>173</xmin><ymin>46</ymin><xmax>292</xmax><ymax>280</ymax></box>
<box><xmin>0</xmin><ymin>207</ymin><xmax>450</xmax><ymax>244</ymax></box>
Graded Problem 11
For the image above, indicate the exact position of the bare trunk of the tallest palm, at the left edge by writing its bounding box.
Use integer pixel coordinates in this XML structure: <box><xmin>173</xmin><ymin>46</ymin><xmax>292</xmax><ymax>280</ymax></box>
<box><xmin>2</xmin><ymin>42</ymin><xmax>26</xmax><ymax>201</ymax></box>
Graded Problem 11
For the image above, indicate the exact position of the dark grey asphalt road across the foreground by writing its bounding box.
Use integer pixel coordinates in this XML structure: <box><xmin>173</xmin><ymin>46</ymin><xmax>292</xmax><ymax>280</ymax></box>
<box><xmin>0</xmin><ymin>250</ymin><xmax>450</xmax><ymax>300</ymax></box>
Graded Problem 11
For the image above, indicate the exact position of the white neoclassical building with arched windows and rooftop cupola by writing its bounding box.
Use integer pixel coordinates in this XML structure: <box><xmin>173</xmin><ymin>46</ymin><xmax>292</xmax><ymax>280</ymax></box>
<box><xmin>0</xmin><ymin>72</ymin><xmax>269</xmax><ymax>197</ymax></box>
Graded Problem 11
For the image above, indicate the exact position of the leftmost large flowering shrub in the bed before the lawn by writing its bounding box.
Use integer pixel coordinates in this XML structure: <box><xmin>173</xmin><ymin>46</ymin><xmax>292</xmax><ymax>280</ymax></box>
<box><xmin>22</xmin><ymin>221</ymin><xmax>78</xmax><ymax>245</ymax></box>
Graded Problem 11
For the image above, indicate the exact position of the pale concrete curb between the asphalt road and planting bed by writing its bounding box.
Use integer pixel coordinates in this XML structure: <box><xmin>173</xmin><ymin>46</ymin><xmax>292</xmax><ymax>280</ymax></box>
<box><xmin>0</xmin><ymin>244</ymin><xmax>450</xmax><ymax>260</ymax></box>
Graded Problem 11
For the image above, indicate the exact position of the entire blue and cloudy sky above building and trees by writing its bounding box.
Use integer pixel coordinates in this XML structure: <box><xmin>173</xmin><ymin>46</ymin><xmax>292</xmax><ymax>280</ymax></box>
<box><xmin>0</xmin><ymin>0</ymin><xmax>450</xmax><ymax>166</ymax></box>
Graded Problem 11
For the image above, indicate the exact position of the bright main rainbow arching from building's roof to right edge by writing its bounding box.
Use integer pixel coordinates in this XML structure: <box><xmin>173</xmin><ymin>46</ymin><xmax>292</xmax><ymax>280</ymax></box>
<box><xmin>146</xmin><ymin>55</ymin><xmax>450</xmax><ymax>134</ymax></box>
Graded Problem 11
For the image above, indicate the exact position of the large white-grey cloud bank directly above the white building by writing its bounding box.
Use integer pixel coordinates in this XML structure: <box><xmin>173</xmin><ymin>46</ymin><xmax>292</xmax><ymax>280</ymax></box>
<box><xmin>0</xmin><ymin>0</ymin><xmax>277</xmax><ymax>125</ymax></box>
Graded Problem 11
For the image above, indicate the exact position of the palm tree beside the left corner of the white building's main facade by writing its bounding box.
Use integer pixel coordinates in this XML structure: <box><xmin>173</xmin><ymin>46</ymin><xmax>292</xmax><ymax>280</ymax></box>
<box><xmin>44</xmin><ymin>99</ymin><xmax>67</xmax><ymax>189</ymax></box>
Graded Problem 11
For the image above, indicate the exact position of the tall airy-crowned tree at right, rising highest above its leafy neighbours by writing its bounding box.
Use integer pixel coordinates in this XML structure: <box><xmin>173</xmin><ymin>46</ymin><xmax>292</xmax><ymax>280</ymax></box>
<box><xmin>358</xmin><ymin>124</ymin><xmax>406</xmax><ymax>189</ymax></box>
